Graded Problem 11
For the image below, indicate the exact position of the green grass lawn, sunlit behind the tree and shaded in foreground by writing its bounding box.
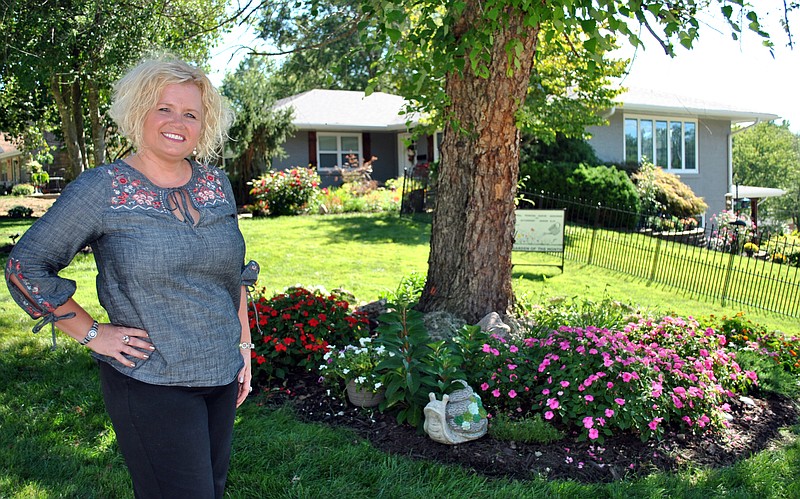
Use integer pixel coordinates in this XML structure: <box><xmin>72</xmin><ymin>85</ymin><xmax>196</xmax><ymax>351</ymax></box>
<box><xmin>0</xmin><ymin>215</ymin><xmax>800</xmax><ymax>498</ymax></box>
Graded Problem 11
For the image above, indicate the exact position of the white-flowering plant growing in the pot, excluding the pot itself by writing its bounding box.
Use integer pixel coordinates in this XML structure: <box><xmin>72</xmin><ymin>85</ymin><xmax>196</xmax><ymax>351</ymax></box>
<box><xmin>319</xmin><ymin>337</ymin><xmax>388</xmax><ymax>393</ymax></box>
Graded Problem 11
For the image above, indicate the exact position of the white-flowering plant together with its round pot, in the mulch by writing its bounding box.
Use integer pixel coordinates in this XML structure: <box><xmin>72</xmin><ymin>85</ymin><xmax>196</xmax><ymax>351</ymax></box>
<box><xmin>319</xmin><ymin>337</ymin><xmax>388</xmax><ymax>407</ymax></box>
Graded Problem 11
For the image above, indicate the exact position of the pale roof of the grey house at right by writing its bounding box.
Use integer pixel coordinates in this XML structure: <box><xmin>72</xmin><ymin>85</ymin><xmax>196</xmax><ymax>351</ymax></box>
<box><xmin>612</xmin><ymin>87</ymin><xmax>780</xmax><ymax>123</ymax></box>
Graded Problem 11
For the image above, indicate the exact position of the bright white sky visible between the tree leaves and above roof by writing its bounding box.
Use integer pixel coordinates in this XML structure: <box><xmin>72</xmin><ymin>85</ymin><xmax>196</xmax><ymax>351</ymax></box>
<box><xmin>209</xmin><ymin>0</ymin><xmax>800</xmax><ymax>133</ymax></box>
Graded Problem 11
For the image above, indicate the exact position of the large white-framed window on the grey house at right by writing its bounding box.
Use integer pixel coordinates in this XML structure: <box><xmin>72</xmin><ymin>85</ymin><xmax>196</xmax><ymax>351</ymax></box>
<box><xmin>625</xmin><ymin>116</ymin><xmax>697</xmax><ymax>171</ymax></box>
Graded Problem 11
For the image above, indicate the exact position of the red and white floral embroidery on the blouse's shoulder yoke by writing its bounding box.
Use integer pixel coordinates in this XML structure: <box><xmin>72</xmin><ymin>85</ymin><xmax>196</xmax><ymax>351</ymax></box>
<box><xmin>108</xmin><ymin>164</ymin><xmax>228</xmax><ymax>212</ymax></box>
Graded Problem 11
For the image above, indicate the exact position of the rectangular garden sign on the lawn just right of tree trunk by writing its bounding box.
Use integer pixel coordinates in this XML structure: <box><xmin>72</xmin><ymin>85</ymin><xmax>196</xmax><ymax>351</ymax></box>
<box><xmin>513</xmin><ymin>210</ymin><xmax>565</xmax><ymax>253</ymax></box>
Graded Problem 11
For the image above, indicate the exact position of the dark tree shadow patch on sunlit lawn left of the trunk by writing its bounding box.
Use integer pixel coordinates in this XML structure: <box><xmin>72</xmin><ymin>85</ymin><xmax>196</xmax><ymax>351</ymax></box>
<box><xmin>311</xmin><ymin>213</ymin><xmax>431</xmax><ymax>246</ymax></box>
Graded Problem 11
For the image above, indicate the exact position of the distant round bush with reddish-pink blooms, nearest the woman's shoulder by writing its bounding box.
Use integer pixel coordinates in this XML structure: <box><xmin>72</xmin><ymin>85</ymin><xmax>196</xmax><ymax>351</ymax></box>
<box><xmin>248</xmin><ymin>168</ymin><xmax>319</xmax><ymax>216</ymax></box>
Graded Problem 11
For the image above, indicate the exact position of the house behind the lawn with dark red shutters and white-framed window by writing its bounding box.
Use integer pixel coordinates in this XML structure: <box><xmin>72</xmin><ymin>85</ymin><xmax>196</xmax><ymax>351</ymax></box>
<box><xmin>272</xmin><ymin>90</ymin><xmax>441</xmax><ymax>185</ymax></box>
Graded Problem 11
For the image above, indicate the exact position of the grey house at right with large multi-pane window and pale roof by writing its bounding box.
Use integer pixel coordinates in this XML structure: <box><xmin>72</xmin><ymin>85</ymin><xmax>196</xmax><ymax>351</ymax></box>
<box><xmin>587</xmin><ymin>88</ymin><xmax>778</xmax><ymax>216</ymax></box>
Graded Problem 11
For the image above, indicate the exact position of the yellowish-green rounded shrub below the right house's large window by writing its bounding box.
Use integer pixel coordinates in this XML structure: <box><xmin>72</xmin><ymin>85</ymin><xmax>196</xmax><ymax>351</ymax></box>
<box><xmin>632</xmin><ymin>163</ymin><xmax>708</xmax><ymax>218</ymax></box>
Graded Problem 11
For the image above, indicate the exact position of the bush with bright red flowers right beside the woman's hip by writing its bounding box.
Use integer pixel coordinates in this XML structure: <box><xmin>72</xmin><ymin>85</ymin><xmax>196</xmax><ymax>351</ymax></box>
<box><xmin>248</xmin><ymin>287</ymin><xmax>369</xmax><ymax>379</ymax></box>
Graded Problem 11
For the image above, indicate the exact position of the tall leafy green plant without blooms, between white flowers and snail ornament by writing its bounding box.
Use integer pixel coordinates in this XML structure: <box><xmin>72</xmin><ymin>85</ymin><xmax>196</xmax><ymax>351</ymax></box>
<box><xmin>377</xmin><ymin>306</ymin><xmax>466</xmax><ymax>429</ymax></box>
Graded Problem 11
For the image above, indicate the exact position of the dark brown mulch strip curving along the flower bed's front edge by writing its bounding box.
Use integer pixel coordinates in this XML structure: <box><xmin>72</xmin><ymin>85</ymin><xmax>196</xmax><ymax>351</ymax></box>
<box><xmin>261</xmin><ymin>375</ymin><xmax>800</xmax><ymax>483</ymax></box>
